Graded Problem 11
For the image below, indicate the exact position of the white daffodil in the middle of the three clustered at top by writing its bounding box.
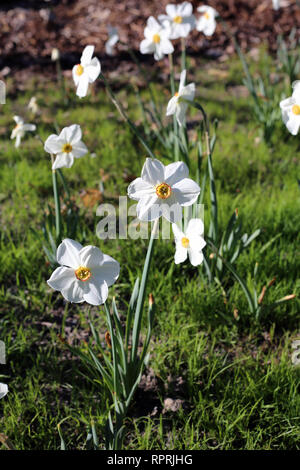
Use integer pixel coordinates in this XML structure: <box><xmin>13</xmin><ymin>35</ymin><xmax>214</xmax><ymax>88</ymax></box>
<box><xmin>158</xmin><ymin>2</ymin><xmax>196</xmax><ymax>39</ymax></box>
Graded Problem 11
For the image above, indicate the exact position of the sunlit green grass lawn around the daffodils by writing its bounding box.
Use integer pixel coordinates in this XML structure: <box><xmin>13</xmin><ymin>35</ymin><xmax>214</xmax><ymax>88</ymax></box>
<box><xmin>0</xmin><ymin>48</ymin><xmax>300</xmax><ymax>450</ymax></box>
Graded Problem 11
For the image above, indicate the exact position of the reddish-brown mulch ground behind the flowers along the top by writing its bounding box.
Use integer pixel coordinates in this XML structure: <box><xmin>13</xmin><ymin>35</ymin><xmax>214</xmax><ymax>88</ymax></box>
<box><xmin>0</xmin><ymin>0</ymin><xmax>300</xmax><ymax>80</ymax></box>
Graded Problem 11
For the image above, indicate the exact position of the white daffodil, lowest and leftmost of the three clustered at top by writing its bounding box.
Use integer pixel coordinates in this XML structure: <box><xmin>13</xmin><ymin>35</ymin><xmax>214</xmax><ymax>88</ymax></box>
<box><xmin>140</xmin><ymin>16</ymin><xmax>174</xmax><ymax>60</ymax></box>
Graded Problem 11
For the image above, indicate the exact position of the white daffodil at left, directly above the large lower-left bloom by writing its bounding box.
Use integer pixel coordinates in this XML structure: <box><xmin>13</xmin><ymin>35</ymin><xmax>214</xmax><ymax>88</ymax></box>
<box><xmin>44</xmin><ymin>124</ymin><xmax>88</xmax><ymax>170</ymax></box>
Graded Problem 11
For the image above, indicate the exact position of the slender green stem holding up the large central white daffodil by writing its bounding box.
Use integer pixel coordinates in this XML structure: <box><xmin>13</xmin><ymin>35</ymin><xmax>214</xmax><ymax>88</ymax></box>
<box><xmin>131</xmin><ymin>219</ymin><xmax>159</xmax><ymax>362</ymax></box>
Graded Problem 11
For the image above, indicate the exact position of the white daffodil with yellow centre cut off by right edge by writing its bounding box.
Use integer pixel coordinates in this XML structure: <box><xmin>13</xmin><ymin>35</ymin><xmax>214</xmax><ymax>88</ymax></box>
<box><xmin>280</xmin><ymin>80</ymin><xmax>300</xmax><ymax>135</ymax></box>
